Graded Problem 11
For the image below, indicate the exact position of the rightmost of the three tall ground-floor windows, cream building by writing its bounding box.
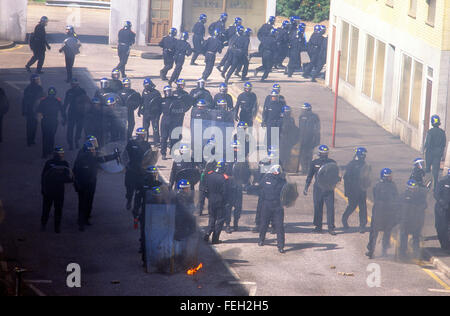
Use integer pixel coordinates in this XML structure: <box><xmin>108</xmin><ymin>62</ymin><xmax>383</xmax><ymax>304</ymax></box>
<box><xmin>398</xmin><ymin>55</ymin><xmax>423</xmax><ymax>128</ymax></box>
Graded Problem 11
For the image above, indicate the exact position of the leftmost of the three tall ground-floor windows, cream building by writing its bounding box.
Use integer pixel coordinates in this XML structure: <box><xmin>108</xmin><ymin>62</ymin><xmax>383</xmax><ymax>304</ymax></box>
<box><xmin>339</xmin><ymin>22</ymin><xmax>359</xmax><ymax>86</ymax></box>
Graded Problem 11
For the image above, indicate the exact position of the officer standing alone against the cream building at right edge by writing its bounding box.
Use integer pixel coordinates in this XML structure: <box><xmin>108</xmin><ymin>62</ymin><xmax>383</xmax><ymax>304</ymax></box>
<box><xmin>423</xmin><ymin>115</ymin><xmax>447</xmax><ymax>189</ymax></box>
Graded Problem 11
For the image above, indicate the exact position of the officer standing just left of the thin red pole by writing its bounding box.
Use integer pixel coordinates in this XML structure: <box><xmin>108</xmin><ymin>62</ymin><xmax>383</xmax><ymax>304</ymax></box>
<box><xmin>298</xmin><ymin>103</ymin><xmax>320</xmax><ymax>175</ymax></box>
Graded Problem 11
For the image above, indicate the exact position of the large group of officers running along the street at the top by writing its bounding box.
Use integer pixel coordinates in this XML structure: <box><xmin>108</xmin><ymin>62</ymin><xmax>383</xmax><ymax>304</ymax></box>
<box><xmin>155</xmin><ymin>13</ymin><xmax>327</xmax><ymax>85</ymax></box>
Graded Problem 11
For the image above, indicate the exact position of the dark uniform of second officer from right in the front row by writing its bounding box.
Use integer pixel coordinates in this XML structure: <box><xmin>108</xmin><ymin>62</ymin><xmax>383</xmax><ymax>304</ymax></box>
<box><xmin>399</xmin><ymin>186</ymin><xmax>427</xmax><ymax>257</ymax></box>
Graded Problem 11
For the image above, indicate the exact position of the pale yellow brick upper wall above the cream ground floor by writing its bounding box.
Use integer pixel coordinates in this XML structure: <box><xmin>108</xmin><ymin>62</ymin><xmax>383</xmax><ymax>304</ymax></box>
<box><xmin>338</xmin><ymin>0</ymin><xmax>450</xmax><ymax>50</ymax></box>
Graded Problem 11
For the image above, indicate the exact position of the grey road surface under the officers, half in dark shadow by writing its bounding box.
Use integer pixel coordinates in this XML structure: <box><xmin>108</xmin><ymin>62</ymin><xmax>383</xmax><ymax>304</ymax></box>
<box><xmin>0</xmin><ymin>4</ymin><xmax>450</xmax><ymax>296</ymax></box>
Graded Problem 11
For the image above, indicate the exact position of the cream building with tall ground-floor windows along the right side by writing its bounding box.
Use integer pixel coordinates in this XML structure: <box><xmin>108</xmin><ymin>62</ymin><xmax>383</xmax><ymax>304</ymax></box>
<box><xmin>326</xmin><ymin>0</ymin><xmax>450</xmax><ymax>150</ymax></box>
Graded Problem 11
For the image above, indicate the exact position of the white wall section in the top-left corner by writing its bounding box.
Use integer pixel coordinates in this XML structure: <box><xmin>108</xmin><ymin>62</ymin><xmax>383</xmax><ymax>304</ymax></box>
<box><xmin>0</xmin><ymin>0</ymin><xmax>28</xmax><ymax>42</ymax></box>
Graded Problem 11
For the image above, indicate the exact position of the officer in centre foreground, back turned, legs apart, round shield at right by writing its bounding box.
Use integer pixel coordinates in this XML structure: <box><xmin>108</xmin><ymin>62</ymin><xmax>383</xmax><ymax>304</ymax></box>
<box><xmin>258</xmin><ymin>165</ymin><xmax>286</xmax><ymax>253</ymax></box>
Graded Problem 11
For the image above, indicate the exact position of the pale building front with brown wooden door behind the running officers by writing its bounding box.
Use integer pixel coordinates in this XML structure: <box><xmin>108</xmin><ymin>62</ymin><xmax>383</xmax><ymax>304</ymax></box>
<box><xmin>109</xmin><ymin>0</ymin><xmax>276</xmax><ymax>45</ymax></box>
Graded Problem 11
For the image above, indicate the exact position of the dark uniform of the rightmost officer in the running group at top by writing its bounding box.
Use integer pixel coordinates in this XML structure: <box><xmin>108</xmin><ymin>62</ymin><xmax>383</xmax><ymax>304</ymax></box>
<box><xmin>303</xmin><ymin>32</ymin><xmax>327</xmax><ymax>81</ymax></box>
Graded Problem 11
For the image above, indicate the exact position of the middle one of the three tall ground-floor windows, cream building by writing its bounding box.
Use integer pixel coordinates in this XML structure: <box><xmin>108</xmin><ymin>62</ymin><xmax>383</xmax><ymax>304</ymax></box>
<box><xmin>363</xmin><ymin>35</ymin><xmax>386</xmax><ymax>104</ymax></box>
